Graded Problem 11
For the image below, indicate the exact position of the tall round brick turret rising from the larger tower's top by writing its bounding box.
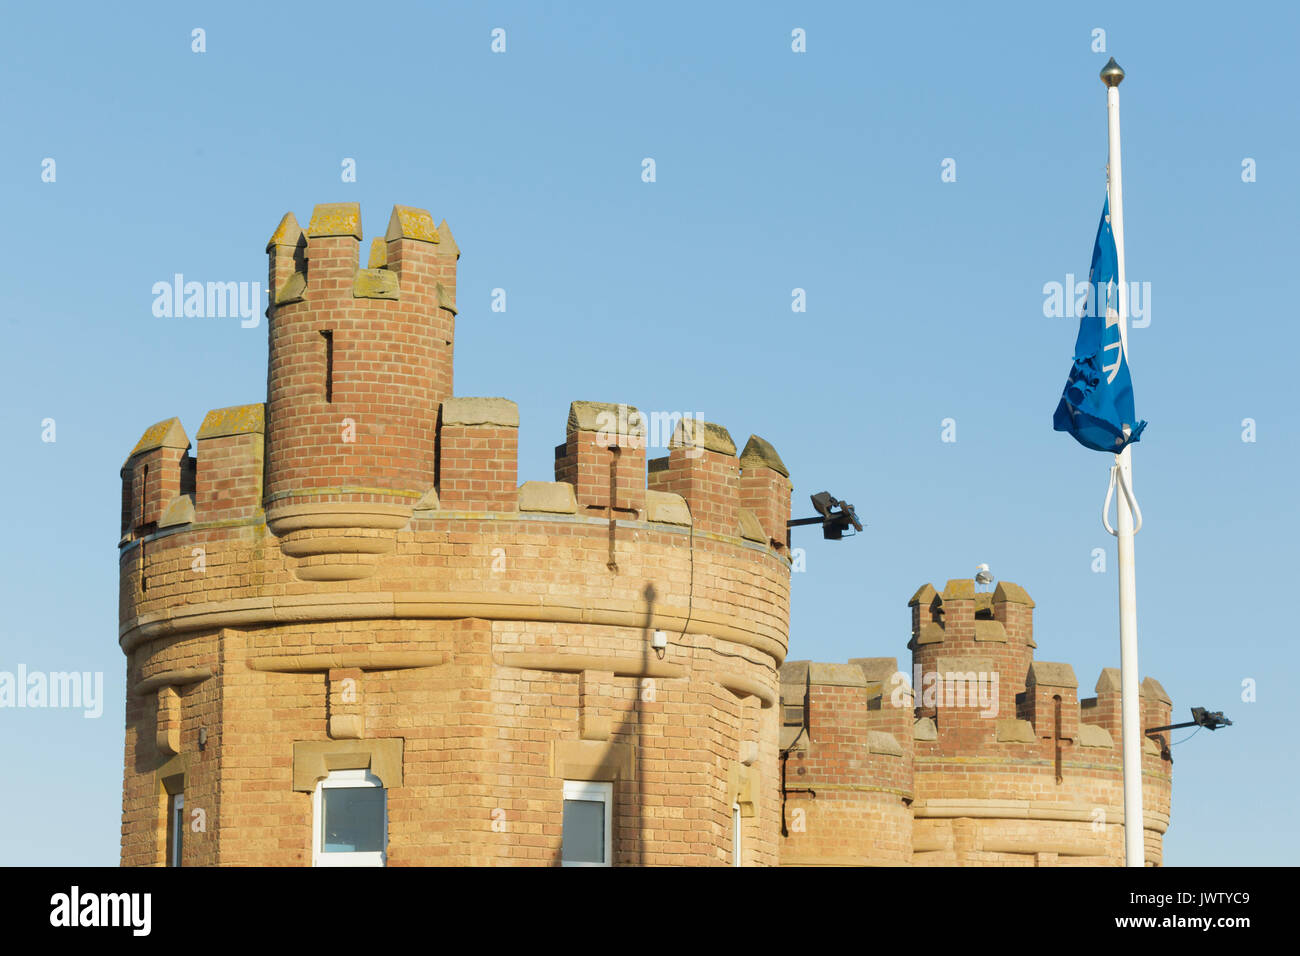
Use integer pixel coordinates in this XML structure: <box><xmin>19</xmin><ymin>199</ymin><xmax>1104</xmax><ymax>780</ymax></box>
<box><xmin>264</xmin><ymin>203</ymin><xmax>459</xmax><ymax>579</ymax></box>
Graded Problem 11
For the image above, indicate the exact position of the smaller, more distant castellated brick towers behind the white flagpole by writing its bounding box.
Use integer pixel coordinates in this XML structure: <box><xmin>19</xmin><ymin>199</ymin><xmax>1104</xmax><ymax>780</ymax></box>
<box><xmin>780</xmin><ymin>580</ymin><xmax>1171</xmax><ymax>866</ymax></box>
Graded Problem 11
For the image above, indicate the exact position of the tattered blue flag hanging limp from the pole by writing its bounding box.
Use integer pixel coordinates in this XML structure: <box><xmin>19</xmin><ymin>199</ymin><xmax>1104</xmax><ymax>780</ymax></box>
<box><xmin>1052</xmin><ymin>196</ymin><xmax>1147</xmax><ymax>454</ymax></box>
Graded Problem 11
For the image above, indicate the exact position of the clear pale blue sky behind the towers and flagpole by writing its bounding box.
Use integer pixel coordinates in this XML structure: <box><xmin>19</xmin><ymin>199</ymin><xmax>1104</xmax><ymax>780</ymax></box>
<box><xmin>0</xmin><ymin>3</ymin><xmax>1300</xmax><ymax>865</ymax></box>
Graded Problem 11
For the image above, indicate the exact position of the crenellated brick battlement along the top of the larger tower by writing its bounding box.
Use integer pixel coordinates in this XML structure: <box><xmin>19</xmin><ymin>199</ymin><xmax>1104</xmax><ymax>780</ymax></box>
<box><xmin>122</xmin><ymin>397</ymin><xmax>790</xmax><ymax>567</ymax></box>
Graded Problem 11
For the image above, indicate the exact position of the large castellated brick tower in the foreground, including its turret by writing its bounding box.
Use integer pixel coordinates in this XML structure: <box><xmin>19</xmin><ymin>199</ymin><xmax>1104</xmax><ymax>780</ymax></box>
<box><xmin>120</xmin><ymin>203</ymin><xmax>790</xmax><ymax>866</ymax></box>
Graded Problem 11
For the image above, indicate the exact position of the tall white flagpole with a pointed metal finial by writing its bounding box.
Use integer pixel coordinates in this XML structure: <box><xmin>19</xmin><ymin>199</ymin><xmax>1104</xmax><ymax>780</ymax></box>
<box><xmin>1101</xmin><ymin>59</ymin><xmax>1147</xmax><ymax>866</ymax></box>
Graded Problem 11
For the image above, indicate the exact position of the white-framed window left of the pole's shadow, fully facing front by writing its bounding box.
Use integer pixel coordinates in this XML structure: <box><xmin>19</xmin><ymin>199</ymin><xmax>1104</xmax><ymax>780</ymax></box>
<box><xmin>312</xmin><ymin>770</ymin><xmax>389</xmax><ymax>866</ymax></box>
